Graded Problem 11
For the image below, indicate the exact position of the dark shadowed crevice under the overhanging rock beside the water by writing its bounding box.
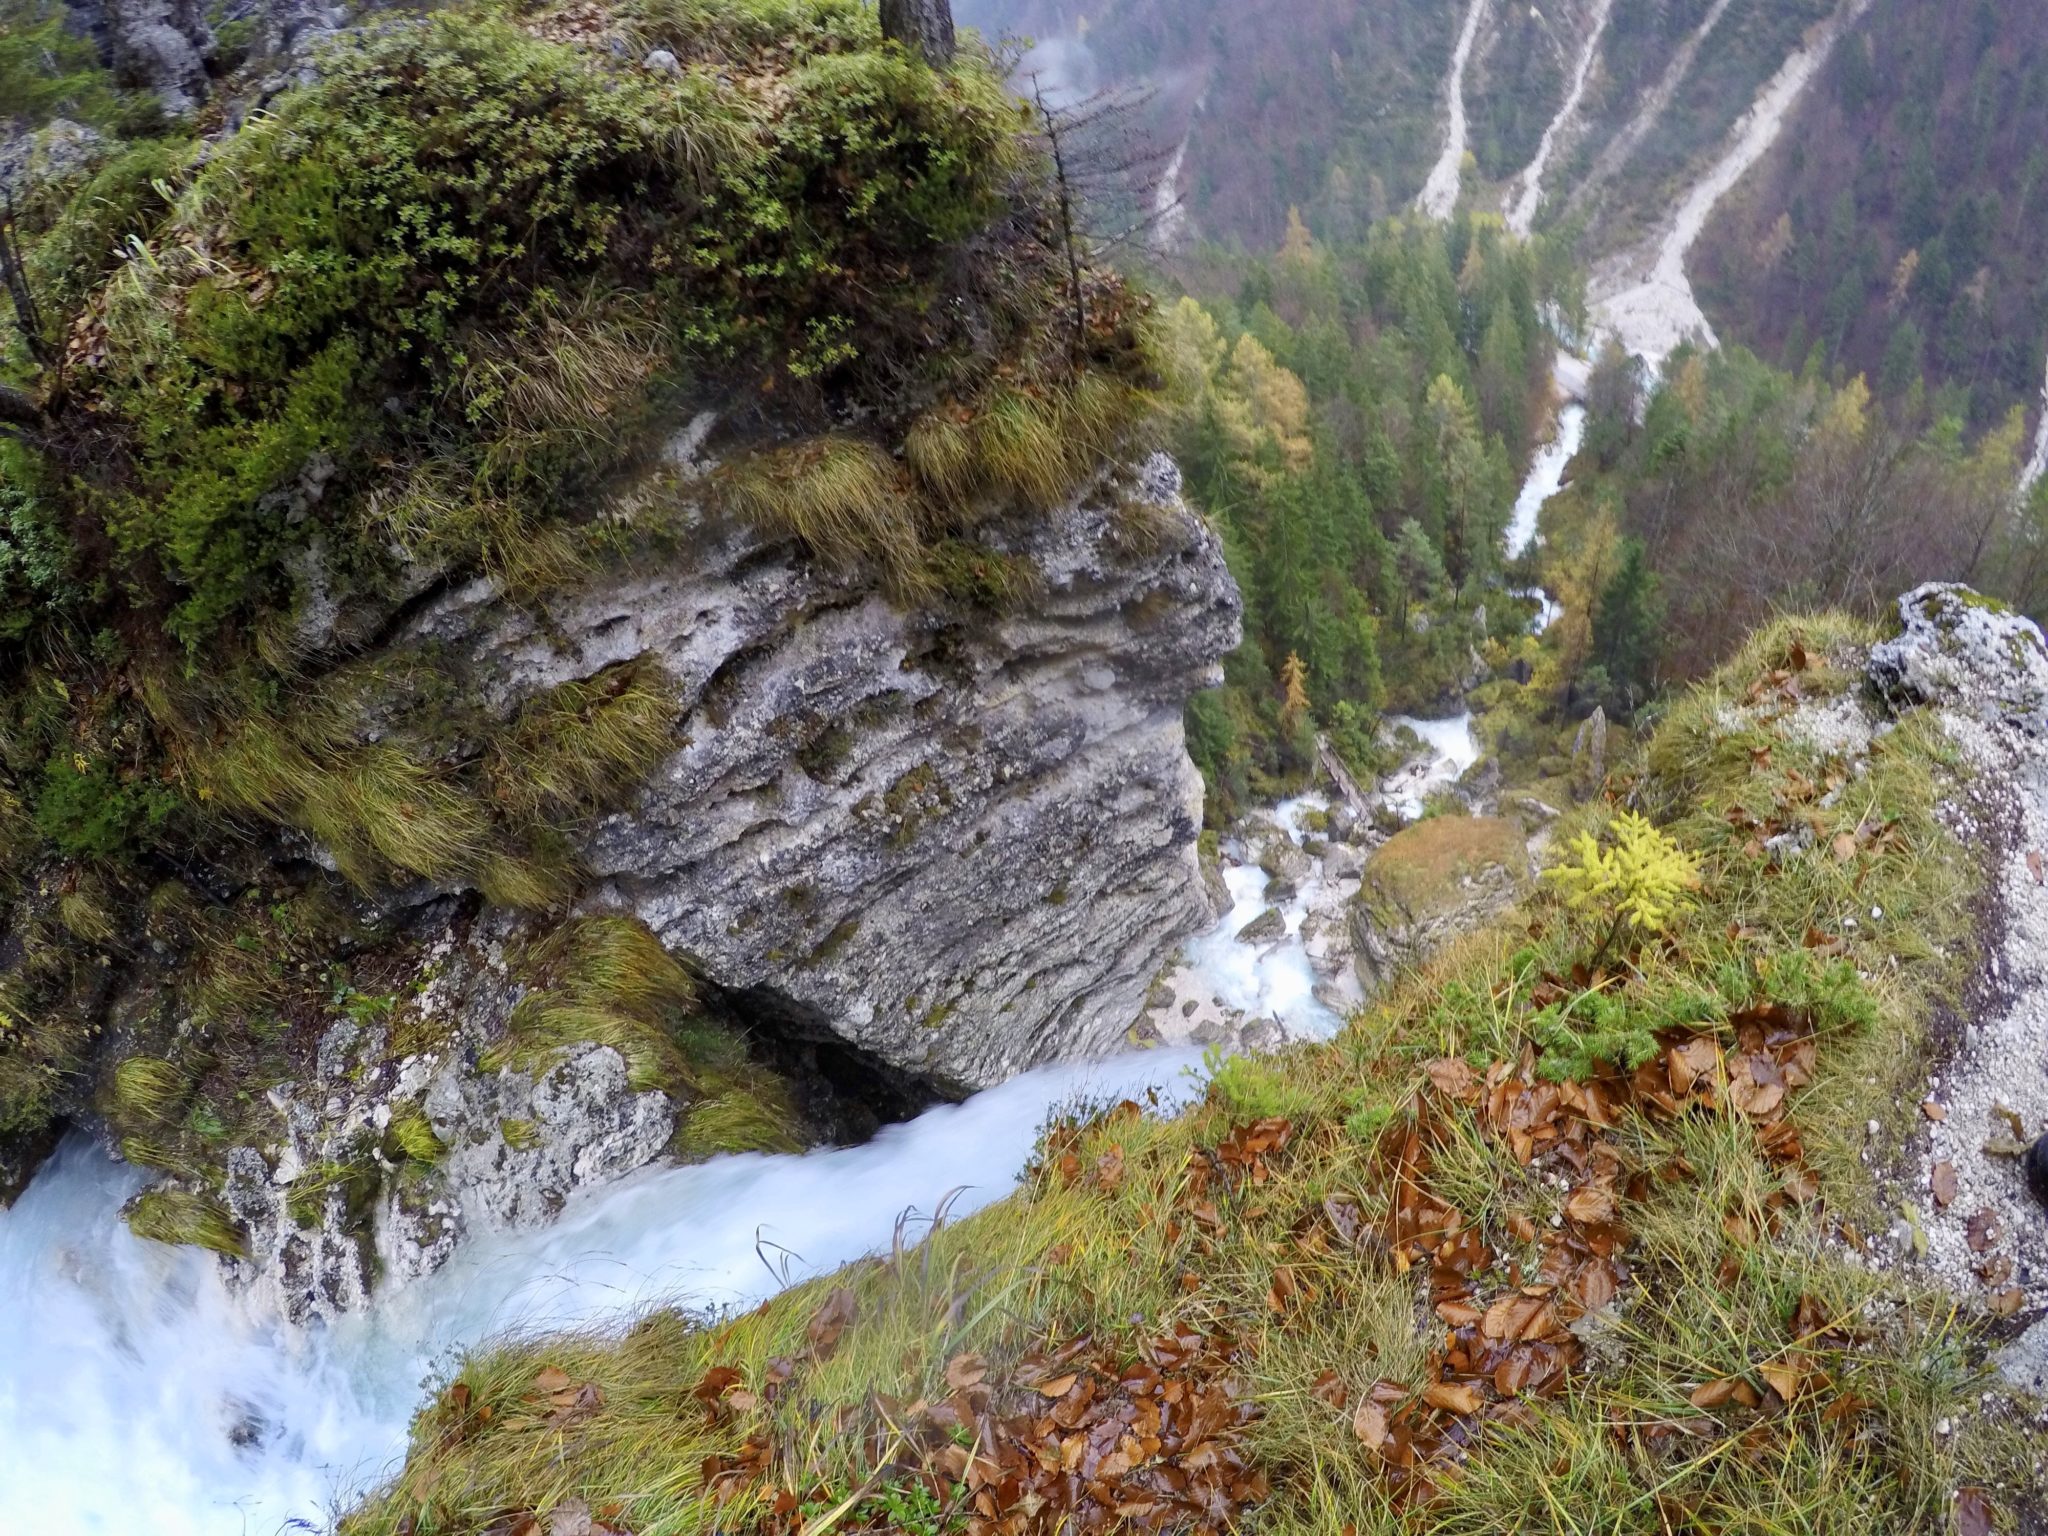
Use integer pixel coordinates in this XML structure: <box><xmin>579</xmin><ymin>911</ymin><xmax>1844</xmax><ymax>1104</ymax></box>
<box><xmin>698</xmin><ymin>981</ymin><xmax>967</xmax><ymax>1145</ymax></box>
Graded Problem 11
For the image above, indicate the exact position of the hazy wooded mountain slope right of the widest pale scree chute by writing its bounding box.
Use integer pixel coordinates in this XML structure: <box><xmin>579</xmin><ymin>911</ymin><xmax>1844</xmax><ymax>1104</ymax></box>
<box><xmin>1692</xmin><ymin>0</ymin><xmax>2048</xmax><ymax>424</ymax></box>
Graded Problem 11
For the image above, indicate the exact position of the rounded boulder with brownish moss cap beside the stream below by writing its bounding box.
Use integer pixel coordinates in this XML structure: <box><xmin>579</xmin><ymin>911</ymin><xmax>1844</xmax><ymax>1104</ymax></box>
<box><xmin>1352</xmin><ymin>815</ymin><xmax>1530</xmax><ymax>993</ymax></box>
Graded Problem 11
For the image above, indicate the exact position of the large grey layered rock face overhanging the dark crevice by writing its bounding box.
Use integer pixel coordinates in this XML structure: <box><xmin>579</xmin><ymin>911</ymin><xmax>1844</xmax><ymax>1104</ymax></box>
<box><xmin>399</xmin><ymin>457</ymin><xmax>1239</xmax><ymax>1090</ymax></box>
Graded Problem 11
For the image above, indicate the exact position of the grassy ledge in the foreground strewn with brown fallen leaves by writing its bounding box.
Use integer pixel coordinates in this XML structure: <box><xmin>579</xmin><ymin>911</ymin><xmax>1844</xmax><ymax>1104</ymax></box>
<box><xmin>344</xmin><ymin>621</ymin><xmax>2040</xmax><ymax>1536</ymax></box>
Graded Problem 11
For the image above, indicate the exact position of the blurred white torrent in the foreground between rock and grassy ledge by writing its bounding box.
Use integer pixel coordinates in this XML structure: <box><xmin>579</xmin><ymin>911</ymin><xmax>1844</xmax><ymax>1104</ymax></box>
<box><xmin>0</xmin><ymin>1051</ymin><xmax>1200</xmax><ymax>1536</ymax></box>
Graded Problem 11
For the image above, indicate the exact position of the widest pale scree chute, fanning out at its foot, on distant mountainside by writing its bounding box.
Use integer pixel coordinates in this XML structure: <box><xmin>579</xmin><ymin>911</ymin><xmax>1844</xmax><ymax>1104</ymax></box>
<box><xmin>1593</xmin><ymin>0</ymin><xmax>1870</xmax><ymax>367</ymax></box>
